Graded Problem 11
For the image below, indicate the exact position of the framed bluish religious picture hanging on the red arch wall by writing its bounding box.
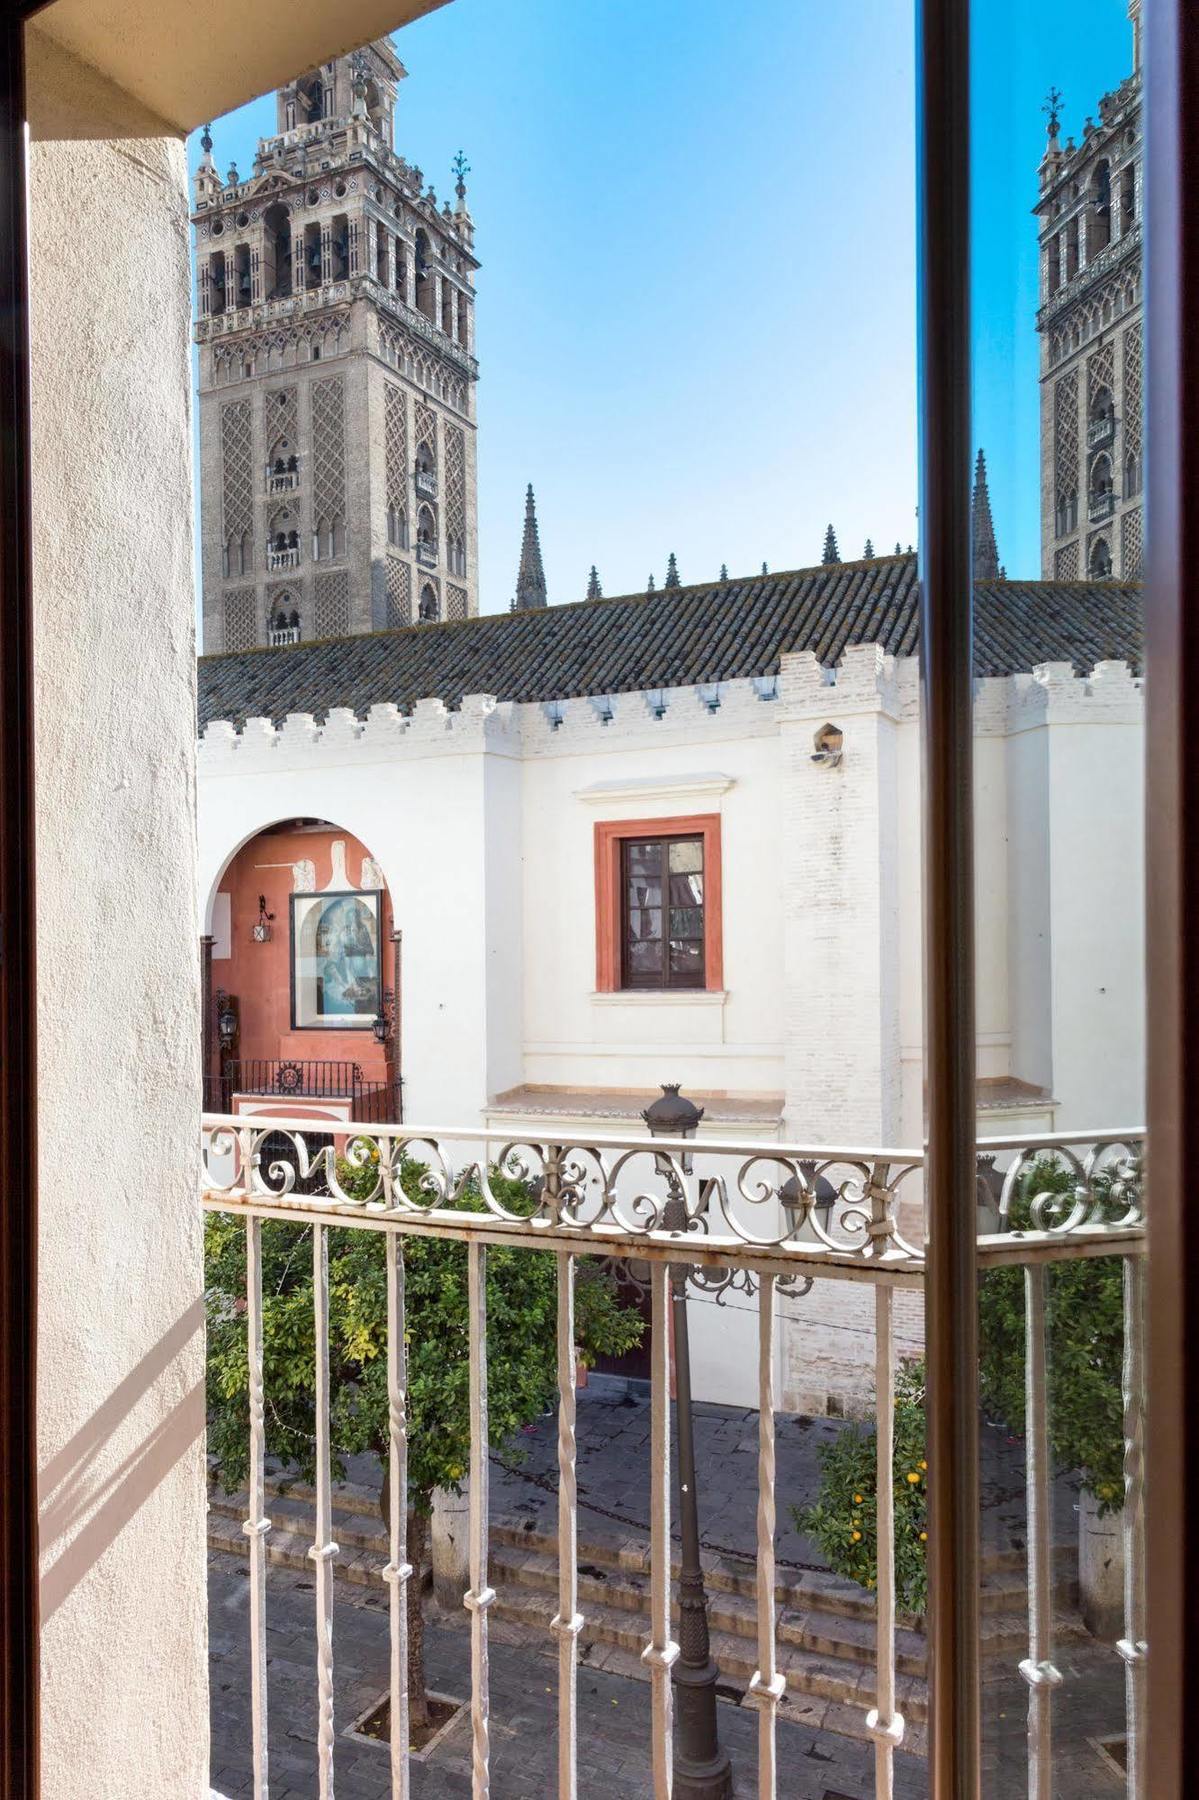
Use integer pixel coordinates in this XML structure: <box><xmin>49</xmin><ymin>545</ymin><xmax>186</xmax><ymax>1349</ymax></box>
<box><xmin>292</xmin><ymin>893</ymin><xmax>383</xmax><ymax>1031</ymax></box>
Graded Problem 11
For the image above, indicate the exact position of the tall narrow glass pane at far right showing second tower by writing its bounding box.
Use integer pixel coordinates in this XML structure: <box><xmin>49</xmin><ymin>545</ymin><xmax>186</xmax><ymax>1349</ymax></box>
<box><xmin>970</xmin><ymin>0</ymin><xmax>1145</xmax><ymax>1796</ymax></box>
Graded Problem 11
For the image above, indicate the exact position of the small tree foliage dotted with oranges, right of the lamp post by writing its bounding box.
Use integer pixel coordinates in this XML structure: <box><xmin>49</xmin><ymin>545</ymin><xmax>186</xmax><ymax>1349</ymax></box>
<box><xmin>792</xmin><ymin>1361</ymin><xmax>927</xmax><ymax>1613</ymax></box>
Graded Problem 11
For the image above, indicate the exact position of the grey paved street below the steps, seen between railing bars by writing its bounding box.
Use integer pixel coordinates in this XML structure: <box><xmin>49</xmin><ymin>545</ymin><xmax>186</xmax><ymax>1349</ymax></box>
<box><xmin>209</xmin><ymin>1555</ymin><xmax>1123</xmax><ymax>1800</ymax></box>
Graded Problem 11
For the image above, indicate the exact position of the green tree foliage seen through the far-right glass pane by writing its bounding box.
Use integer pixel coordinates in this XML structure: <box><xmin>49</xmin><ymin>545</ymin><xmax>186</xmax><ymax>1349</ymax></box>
<box><xmin>978</xmin><ymin>1157</ymin><xmax>1123</xmax><ymax>1514</ymax></box>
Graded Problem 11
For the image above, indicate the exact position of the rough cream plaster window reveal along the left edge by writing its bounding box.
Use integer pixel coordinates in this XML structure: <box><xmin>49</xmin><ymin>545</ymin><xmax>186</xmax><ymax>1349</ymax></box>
<box><xmin>29</xmin><ymin>31</ymin><xmax>207</xmax><ymax>1800</ymax></box>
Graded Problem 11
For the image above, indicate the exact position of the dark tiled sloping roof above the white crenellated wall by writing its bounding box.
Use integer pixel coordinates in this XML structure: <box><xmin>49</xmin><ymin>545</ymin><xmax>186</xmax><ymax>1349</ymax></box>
<box><xmin>200</xmin><ymin>556</ymin><xmax>1143</xmax><ymax>727</ymax></box>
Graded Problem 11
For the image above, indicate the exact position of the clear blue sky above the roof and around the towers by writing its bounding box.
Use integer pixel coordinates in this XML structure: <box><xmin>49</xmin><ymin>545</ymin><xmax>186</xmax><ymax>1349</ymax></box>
<box><xmin>189</xmin><ymin>0</ymin><xmax>1131</xmax><ymax>612</ymax></box>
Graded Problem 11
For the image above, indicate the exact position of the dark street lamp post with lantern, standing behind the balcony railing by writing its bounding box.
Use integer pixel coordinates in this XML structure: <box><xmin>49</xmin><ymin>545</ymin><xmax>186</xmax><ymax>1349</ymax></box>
<box><xmin>641</xmin><ymin>1082</ymin><xmax>733</xmax><ymax>1800</ymax></box>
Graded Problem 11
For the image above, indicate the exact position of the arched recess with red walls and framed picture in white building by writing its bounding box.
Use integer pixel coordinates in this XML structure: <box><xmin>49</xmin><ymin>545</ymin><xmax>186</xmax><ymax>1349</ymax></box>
<box><xmin>203</xmin><ymin>819</ymin><xmax>401</xmax><ymax>1123</ymax></box>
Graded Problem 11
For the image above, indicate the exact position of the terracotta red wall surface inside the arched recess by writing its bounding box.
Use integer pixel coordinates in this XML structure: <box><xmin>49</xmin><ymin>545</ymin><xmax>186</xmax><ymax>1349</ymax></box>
<box><xmin>212</xmin><ymin>828</ymin><xmax>392</xmax><ymax>1082</ymax></box>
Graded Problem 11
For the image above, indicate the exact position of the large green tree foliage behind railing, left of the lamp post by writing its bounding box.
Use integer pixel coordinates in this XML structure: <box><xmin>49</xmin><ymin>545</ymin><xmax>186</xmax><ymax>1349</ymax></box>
<box><xmin>205</xmin><ymin>1152</ymin><xmax>643</xmax><ymax>1512</ymax></box>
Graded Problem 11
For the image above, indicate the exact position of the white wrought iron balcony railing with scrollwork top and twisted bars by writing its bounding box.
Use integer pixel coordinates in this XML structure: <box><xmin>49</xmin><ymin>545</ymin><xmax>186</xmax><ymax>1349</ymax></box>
<box><xmin>202</xmin><ymin>1112</ymin><xmax>1147</xmax><ymax>1800</ymax></box>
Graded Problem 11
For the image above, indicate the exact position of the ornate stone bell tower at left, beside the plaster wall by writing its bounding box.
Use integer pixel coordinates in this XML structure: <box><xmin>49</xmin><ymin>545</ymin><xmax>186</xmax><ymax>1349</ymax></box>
<box><xmin>193</xmin><ymin>38</ymin><xmax>479</xmax><ymax>652</ymax></box>
